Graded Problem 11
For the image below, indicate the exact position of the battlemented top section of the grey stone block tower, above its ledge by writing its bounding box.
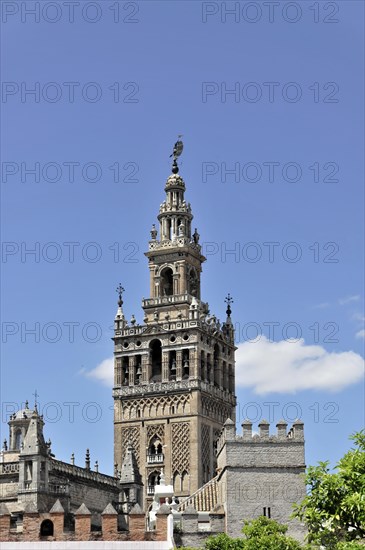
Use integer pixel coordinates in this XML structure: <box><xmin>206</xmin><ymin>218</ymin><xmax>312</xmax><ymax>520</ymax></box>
<box><xmin>217</xmin><ymin>419</ymin><xmax>305</xmax><ymax>468</ymax></box>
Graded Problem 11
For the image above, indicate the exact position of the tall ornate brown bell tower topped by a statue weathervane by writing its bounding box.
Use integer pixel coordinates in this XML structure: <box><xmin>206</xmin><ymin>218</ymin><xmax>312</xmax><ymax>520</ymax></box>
<box><xmin>113</xmin><ymin>141</ymin><xmax>236</xmax><ymax>506</ymax></box>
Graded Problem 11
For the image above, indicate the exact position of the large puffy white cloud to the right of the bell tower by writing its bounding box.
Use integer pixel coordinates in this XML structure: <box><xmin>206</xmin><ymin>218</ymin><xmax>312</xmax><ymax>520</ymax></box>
<box><xmin>236</xmin><ymin>337</ymin><xmax>364</xmax><ymax>395</ymax></box>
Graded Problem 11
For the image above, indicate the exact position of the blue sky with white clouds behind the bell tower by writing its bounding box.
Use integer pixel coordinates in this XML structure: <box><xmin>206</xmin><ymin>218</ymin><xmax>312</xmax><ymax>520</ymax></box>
<box><xmin>1</xmin><ymin>0</ymin><xmax>364</xmax><ymax>473</ymax></box>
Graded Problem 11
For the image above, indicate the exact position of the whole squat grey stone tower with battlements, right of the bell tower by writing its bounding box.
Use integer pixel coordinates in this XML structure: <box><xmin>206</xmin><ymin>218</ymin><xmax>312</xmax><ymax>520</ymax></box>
<box><xmin>217</xmin><ymin>420</ymin><xmax>305</xmax><ymax>540</ymax></box>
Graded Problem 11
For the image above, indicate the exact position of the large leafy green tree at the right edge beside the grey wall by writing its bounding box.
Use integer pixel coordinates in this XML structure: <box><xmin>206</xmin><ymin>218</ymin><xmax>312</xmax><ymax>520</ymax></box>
<box><xmin>293</xmin><ymin>430</ymin><xmax>365</xmax><ymax>550</ymax></box>
